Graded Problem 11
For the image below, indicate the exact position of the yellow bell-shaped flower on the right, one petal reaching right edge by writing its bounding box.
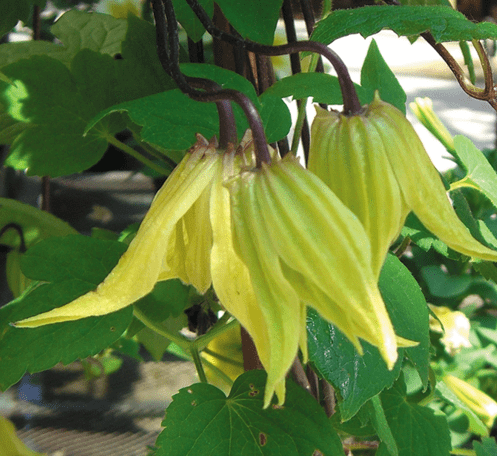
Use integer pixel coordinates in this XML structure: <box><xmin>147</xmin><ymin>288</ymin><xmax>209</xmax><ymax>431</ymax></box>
<box><xmin>308</xmin><ymin>93</ymin><xmax>497</xmax><ymax>278</ymax></box>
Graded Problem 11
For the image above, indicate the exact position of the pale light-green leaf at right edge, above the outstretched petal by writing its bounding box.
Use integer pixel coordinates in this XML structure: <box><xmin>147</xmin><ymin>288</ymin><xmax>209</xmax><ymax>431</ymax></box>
<box><xmin>454</xmin><ymin>135</ymin><xmax>497</xmax><ymax>213</ymax></box>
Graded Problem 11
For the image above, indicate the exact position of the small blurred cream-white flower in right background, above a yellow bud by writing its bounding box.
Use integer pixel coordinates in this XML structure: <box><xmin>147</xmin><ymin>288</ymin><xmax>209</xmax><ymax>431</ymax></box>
<box><xmin>428</xmin><ymin>304</ymin><xmax>471</xmax><ymax>356</ymax></box>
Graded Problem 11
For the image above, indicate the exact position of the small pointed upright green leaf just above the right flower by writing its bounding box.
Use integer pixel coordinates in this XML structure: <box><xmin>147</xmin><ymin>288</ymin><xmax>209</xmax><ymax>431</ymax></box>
<box><xmin>361</xmin><ymin>40</ymin><xmax>407</xmax><ymax>114</ymax></box>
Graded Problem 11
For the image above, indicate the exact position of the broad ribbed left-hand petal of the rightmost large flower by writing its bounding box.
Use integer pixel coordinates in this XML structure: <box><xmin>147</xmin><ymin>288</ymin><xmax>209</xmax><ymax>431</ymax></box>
<box><xmin>308</xmin><ymin>107</ymin><xmax>410</xmax><ymax>279</ymax></box>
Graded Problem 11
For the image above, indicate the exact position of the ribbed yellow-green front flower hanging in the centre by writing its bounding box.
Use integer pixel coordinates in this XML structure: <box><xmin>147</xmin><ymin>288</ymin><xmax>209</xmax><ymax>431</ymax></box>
<box><xmin>227</xmin><ymin>154</ymin><xmax>397</xmax><ymax>396</ymax></box>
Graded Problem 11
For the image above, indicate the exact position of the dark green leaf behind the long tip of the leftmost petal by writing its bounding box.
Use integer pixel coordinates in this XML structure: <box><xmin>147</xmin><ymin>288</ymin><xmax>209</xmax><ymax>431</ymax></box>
<box><xmin>0</xmin><ymin>235</ymin><xmax>132</xmax><ymax>390</ymax></box>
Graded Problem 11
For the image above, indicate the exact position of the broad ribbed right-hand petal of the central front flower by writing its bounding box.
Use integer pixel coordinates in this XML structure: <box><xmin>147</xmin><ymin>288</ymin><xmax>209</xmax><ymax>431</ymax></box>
<box><xmin>256</xmin><ymin>155</ymin><xmax>397</xmax><ymax>368</ymax></box>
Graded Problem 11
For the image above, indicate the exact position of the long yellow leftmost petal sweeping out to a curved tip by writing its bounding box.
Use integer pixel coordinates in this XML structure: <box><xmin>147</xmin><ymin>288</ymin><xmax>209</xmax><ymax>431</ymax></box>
<box><xmin>16</xmin><ymin>141</ymin><xmax>217</xmax><ymax>327</ymax></box>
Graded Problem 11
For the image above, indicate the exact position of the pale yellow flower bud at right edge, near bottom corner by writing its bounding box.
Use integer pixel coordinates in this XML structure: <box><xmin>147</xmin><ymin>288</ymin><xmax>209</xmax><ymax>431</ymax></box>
<box><xmin>442</xmin><ymin>375</ymin><xmax>497</xmax><ymax>428</ymax></box>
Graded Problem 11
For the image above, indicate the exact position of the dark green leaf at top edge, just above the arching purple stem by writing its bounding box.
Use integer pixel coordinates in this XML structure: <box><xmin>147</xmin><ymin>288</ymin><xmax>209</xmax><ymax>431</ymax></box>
<box><xmin>216</xmin><ymin>0</ymin><xmax>283</xmax><ymax>45</ymax></box>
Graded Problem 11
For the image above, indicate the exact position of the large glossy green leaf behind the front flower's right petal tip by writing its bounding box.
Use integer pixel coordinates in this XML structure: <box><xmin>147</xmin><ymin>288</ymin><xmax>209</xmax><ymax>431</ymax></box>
<box><xmin>307</xmin><ymin>255</ymin><xmax>429</xmax><ymax>420</ymax></box>
